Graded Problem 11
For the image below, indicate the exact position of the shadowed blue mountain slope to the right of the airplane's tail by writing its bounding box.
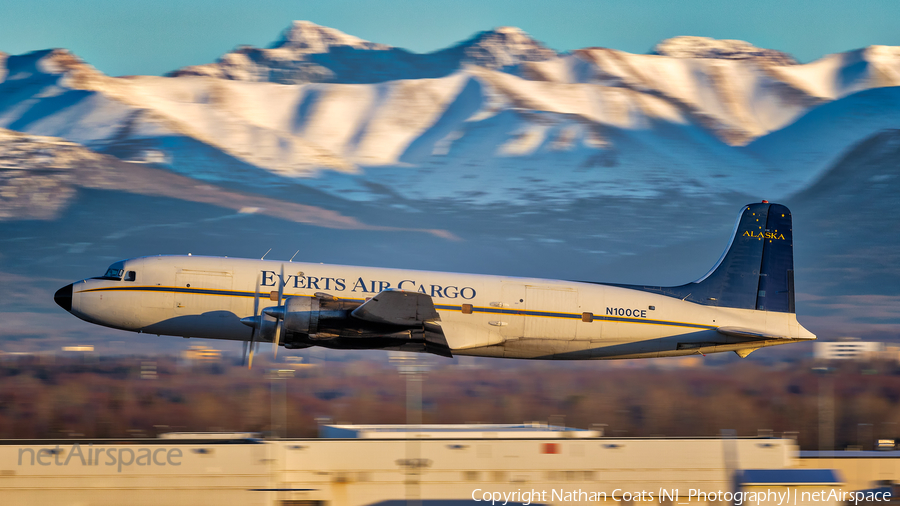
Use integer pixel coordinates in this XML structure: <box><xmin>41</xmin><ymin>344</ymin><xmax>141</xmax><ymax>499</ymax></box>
<box><xmin>789</xmin><ymin>129</ymin><xmax>900</xmax><ymax>335</ymax></box>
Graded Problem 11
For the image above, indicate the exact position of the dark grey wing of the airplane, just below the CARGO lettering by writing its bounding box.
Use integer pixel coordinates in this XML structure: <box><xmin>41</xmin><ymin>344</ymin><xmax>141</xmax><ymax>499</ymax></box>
<box><xmin>350</xmin><ymin>288</ymin><xmax>440</xmax><ymax>326</ymax></box>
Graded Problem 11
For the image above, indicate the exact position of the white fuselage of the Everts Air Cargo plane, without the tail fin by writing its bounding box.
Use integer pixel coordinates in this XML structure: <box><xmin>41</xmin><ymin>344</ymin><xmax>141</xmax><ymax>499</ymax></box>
<box><xmin>71</xmin><ymin>256</ymin><xmax>814</xmax><ymax>359</ymax></box>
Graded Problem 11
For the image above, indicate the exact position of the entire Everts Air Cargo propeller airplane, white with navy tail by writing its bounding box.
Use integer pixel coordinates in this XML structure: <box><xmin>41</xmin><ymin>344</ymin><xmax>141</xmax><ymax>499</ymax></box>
<box><xmin>54</xmin><ymin>201</ymin><xmax>815</xmax><ymax>364</ymax></box>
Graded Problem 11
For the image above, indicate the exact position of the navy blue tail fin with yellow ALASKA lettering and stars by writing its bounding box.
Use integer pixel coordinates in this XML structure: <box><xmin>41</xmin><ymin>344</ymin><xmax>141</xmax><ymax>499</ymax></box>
<box><xmin>618</xmin><ymin>201</ymin><xmax>794</xmax><ymax>313</ymax></box>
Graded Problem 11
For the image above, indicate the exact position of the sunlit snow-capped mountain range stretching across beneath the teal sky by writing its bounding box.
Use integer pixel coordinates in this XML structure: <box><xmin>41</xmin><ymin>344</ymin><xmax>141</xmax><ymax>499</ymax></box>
<box><xmin>0</xmin><ymin>21</ymin><xmax>900</xmax><ymax>204</ymax></box>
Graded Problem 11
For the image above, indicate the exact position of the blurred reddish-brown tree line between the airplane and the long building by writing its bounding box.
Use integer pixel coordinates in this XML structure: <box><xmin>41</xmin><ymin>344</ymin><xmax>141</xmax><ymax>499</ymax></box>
<box><xmin>0</xmin><ymin>357</ymin><xmax>900</xmax><ymax>449</ymax></box>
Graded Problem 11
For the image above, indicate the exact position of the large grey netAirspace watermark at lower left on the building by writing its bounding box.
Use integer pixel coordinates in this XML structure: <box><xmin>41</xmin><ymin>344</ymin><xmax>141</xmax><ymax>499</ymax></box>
<box><xmin>19</xmin><ymin>443</ymin><xmax>182</xmax><ymax>473</ymax></box>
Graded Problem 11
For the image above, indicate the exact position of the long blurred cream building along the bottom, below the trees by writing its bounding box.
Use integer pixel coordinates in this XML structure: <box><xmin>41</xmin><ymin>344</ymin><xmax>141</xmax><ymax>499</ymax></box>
<box><xmin>0</xmin><ymin>424</ymin><xmax>888</xmax><ymax>506</ymax></box>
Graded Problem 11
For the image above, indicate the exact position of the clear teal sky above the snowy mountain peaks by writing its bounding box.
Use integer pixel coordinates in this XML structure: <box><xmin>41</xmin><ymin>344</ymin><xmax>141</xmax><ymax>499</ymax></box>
<box><xmin>0</xmin><ymin>0</ymin><xmax>900</xmax><ymax>75</ymax></box>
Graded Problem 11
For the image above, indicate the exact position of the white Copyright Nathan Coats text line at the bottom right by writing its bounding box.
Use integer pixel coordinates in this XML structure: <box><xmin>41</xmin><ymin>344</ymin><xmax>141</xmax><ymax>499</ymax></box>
<box><xmin>472</xmin><ymin>487</ymin><xmax>891</xmax><ymax>506</ymax></box>
